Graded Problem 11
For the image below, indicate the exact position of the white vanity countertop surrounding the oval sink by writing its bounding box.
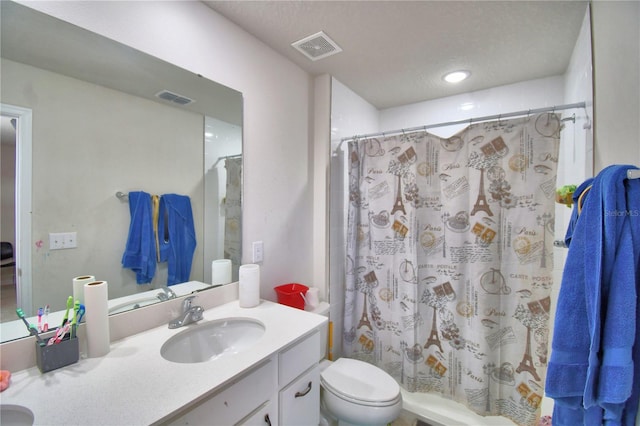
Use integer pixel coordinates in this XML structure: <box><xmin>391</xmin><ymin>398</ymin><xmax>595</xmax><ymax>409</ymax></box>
<box><xmin>0</xmin><ymin>300</ymin><xmax>327</xmax><ymax>425</ymax></box>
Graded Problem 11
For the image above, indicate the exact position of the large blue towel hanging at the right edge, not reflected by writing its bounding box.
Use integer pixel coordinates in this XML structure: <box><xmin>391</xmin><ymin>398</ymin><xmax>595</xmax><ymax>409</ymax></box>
<box><xmin>546</xmin><ymin>166</ymin><xmax>640</xmax><ymax>426</ymax></box>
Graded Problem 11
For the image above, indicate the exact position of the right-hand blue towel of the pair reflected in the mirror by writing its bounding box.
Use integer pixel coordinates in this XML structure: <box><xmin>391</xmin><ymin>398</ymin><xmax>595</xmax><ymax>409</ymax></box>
<box><xmin>158</xmin><ymin>194</ymin><xmax>196</xmax><ymax>285</ymax></box>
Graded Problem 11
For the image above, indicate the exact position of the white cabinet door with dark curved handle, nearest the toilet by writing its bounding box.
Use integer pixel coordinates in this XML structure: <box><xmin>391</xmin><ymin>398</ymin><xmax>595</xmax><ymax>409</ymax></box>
<box><xmin>278</xmin><ymin>365</ymin><xmax>320</xmax><ymax>426</ymax></box>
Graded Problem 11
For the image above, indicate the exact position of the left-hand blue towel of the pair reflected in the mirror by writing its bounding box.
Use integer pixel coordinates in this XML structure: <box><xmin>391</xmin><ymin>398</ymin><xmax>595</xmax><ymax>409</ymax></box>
<box><xmin>122</xmin><ymin>191</ymin><xmax>156</xmax><ymax>284</ymax></box>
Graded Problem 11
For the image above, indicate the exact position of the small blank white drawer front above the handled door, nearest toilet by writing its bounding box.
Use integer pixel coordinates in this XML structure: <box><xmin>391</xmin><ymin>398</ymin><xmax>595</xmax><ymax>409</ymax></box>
<box><xmin>278</xmin><ymin>330</ymin><xmax>320</xmax><ymax>387</ymax></box>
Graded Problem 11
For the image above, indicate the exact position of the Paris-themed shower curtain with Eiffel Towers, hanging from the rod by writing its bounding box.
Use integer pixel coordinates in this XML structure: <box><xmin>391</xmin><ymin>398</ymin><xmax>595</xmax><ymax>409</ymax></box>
<box><xmin>343</xmin><ymin>113</ymin><xmax>561</xmax><ymax>425</ymax></box>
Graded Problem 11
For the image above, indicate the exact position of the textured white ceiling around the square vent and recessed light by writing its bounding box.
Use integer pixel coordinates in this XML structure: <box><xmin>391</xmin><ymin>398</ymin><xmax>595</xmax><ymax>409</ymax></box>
<box><xmin>204</xmin><ymin>0</ymin><xmax>587</xmax><ymax>109</ymax></box>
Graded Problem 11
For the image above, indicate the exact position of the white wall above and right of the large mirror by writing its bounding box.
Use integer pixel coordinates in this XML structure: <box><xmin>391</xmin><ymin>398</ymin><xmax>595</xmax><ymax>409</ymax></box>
<box><xmin>25</xmin><ymin>1</ymin><xmax>313</xmax><ymax>300</ymax></box>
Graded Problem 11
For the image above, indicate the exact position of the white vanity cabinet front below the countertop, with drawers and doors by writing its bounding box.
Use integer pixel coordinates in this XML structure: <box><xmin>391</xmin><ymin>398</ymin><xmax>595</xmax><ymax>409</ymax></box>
<box><xmin>165</xmin><ymin>330</ymin><xmax>320</xmax><ymax>426</ymax></box>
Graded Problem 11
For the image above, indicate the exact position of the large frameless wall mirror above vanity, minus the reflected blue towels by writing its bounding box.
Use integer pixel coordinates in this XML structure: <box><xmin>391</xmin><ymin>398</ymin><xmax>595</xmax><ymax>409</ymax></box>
<box><xmin>0</xmin><ymin>1</ymin><xmax>242</xmax><ymax>341</ymax></box>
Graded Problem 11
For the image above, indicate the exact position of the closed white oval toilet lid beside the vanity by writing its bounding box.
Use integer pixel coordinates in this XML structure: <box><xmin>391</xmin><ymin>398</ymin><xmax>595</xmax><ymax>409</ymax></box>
<box><xmin>321</xmin><ymin>358</ymin><xmax>400</xmax><ymax>402</ymax></box>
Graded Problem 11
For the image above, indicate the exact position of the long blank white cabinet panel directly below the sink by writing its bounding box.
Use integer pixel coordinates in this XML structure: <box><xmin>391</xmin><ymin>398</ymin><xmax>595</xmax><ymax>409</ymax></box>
<box><xmin>169</xmin><ymin>359</ymin><xmax>276</xmax><ymax>425</ymax></box>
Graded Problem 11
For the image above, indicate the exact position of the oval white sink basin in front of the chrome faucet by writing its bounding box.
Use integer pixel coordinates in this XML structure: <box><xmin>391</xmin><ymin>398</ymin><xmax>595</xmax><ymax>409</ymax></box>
<box><xmin>160</xmin><ymin>318</ymin><xmax>264</xmax><ymax>363</ymax></box>
